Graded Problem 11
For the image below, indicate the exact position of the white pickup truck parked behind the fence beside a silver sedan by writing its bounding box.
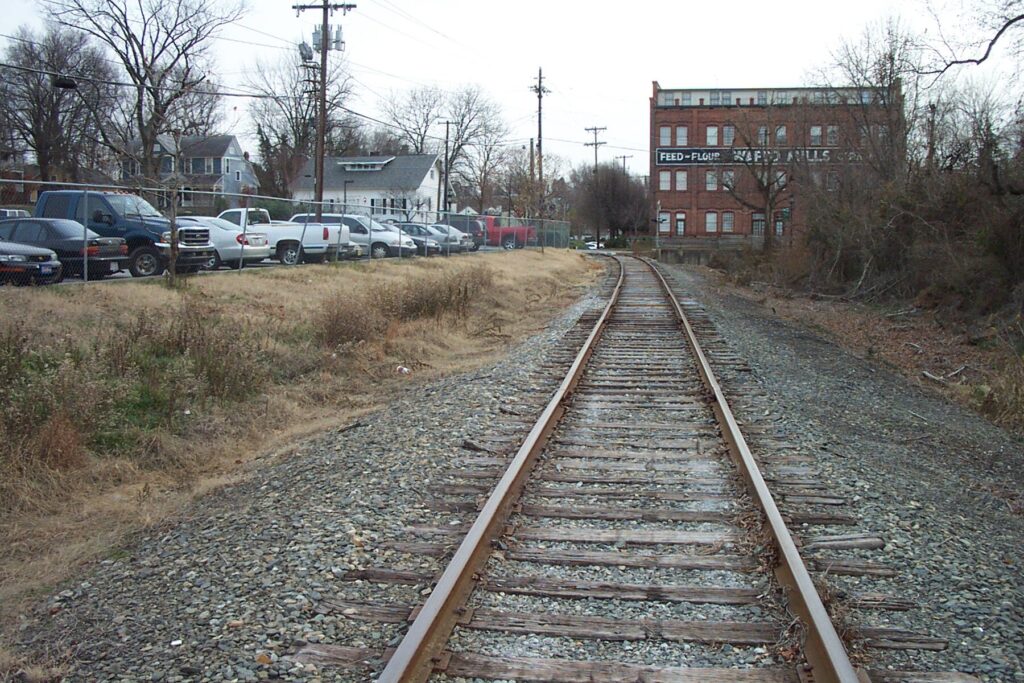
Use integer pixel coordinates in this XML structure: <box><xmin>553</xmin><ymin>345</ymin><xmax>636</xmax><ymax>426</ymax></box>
<box><xmin>217</xmin><ymin>209</ymin><xmax>354</xmax><ymax>265</ymax></box>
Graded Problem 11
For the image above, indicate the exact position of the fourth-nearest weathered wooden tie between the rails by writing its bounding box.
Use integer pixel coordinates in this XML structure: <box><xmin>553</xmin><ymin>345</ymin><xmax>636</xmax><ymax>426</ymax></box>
<box><xmin>505</xmin><ymin>548</ymin><xmax>758</xmax><ymax>572</ymax></box>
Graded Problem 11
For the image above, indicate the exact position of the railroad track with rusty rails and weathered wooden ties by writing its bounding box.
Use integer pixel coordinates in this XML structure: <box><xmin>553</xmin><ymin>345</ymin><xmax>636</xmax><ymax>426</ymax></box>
<box><xmin>294</xmin><ymin>258</ymin><xmax>974</xmax><ymax>683</ymax></box>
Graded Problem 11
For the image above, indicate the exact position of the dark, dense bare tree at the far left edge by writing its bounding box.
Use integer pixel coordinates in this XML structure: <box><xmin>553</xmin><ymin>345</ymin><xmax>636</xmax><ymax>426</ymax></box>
<box><xmin>0</xmin><ymin>28</ymin><xmax>115</xmax><ymax>180</ymax></box>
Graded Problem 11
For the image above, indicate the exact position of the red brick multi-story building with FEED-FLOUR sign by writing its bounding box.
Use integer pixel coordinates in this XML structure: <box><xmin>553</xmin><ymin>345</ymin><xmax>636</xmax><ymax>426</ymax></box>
<box><xmin>650</xmin><ymin>81</ymin><xmax>892</xmax><ymax>244</ymax></box>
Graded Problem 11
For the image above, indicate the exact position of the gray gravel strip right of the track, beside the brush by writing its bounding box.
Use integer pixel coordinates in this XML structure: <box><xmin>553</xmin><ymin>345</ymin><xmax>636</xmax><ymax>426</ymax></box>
<box><xmin>668</xmin><ymin>266</ymin><xmax>1024</xmax><ymax>681</ymax></box>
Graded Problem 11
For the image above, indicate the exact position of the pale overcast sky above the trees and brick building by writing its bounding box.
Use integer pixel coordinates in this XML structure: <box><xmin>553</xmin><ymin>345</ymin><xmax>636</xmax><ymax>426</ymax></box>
<box><xmin>0</xmin><ymin>0</ymin><xmax>1015</xmax><ymax>175</ymax></box>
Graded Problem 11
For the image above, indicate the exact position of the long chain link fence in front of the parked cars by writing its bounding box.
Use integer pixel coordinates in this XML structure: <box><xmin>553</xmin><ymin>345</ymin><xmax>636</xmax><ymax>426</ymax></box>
<box><xmin>0</xmin><ymin>178</ymin><xmax>571</xmax><ymax>282</ymax></box>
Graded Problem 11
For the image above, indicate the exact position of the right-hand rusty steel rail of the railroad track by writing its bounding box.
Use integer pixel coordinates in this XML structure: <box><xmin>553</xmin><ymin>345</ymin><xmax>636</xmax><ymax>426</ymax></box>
<box><xmin>643</xmin><ymin>259</ymin><xmax>869</xmax><ymax>683</ymax></box>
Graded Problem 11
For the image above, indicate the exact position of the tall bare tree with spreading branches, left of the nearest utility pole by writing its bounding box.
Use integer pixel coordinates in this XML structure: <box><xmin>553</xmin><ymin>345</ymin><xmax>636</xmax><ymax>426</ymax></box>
<box><xmin>44</xmin><ymin>0</ymin><xmax>245</xmax><ymax>177</ymax></box>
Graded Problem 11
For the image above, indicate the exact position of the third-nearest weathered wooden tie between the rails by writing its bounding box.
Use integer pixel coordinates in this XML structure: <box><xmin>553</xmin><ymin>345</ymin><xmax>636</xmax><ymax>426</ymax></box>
<box><xmin>480</xmin><ymin>577</ymin><xmax>760</xmax><ymax>605</ymax></box>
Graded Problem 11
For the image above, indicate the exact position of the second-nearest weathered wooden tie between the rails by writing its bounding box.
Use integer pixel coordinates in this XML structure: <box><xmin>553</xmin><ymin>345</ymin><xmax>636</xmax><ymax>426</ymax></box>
<box><xmin>464</xmin><ymin>608</ymin><xmax>784</xmax><ymax>645</ymax></box>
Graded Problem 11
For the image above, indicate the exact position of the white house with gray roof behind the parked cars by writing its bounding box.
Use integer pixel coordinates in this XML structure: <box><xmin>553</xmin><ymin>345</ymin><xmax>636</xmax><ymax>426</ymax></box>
<box><xmin>291</xmin><ymin>155</ymin><xmax>443</xmax><ymax>222</ymax></box>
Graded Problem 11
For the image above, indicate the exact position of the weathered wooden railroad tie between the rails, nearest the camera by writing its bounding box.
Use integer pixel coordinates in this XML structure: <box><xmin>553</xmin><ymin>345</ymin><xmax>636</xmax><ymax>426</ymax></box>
<box><xmin>444</xmin><ymin>652</ymin><xmax>798</xmax><ymax>683</ymax></box>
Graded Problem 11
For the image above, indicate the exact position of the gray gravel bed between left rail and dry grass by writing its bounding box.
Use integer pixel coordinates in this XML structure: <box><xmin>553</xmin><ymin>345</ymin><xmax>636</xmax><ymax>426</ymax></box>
<box><xmin>9</xmin><ymin>284</ymin><xmax>600</xmax><ymax>681</ymax></box>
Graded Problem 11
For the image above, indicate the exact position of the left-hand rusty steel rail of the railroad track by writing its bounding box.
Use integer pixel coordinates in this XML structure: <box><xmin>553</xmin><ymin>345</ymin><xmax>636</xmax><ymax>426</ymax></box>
<box><xmin>377</xmin><ymin>253</ymin><xmax>626</xmax><ymax>683</ymax></box>
